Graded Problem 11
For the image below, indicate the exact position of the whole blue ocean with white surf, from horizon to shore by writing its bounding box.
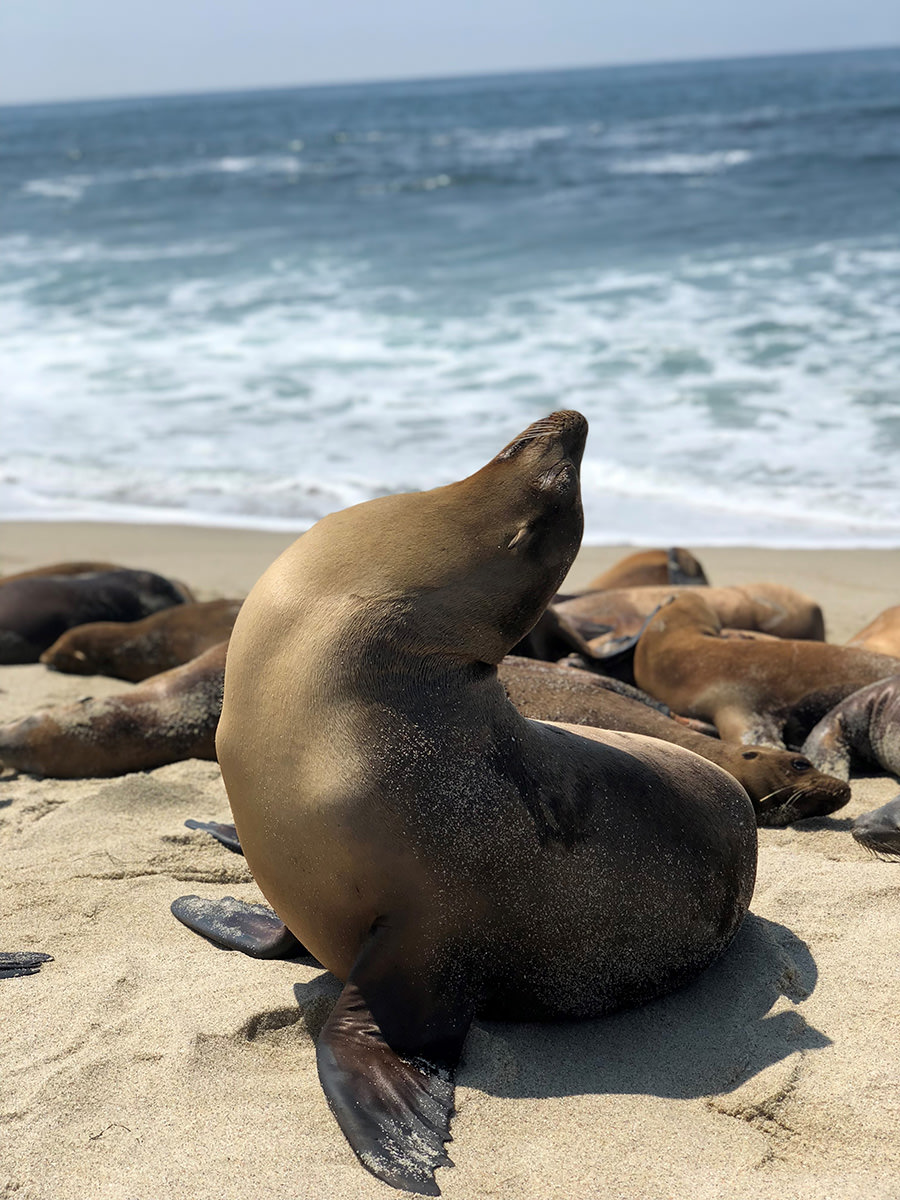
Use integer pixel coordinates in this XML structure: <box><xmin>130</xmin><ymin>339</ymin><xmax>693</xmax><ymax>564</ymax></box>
<box><xmin>0</xmin><ymin>50</ymin><xmax>900</xmax><ymax>546</ymax></box>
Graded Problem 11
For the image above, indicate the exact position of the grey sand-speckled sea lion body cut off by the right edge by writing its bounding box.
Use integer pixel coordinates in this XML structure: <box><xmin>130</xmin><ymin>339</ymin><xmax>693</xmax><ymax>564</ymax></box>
<box><xmin>803</xmin><ymin>674</ymin><xmax>900</xmax><ymax>779</ymax></box>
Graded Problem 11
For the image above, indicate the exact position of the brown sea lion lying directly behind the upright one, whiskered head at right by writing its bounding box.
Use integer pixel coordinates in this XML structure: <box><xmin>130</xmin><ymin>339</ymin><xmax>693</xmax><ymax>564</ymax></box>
<box><xmin>499</xmin><ymin>656</ymin><xmax>850</xmax><ymax>826</ymax></box>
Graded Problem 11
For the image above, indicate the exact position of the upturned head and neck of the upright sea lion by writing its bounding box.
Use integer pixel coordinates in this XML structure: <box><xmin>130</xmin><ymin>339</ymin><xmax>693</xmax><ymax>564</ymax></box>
<box><xmin>292</xmin><ymin>412</ymin><xmax>588</xmax><ymax>664</ymax></box>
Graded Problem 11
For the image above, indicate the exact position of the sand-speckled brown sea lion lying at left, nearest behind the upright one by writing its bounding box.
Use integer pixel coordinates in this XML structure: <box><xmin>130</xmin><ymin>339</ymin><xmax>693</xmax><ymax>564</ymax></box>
<box><xmin>0</xmin><ymin>642</ymin><xmax>228</xmax><ymax>779</ymax></box>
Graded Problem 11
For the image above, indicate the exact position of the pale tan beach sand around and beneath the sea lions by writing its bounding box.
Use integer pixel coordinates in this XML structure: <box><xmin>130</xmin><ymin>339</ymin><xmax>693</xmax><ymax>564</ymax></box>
<box><xmin>0</xmin><ymin>523</ymin><xmax>900</xmax><ymax>1200</ymax></box>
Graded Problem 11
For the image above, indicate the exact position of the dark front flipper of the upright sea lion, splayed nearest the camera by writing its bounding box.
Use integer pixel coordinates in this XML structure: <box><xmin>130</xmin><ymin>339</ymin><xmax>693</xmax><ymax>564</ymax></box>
<box><xmin>317</xmin><ymin>931</ymin><xmax>472</xmax><ymax>1195</ymax></box>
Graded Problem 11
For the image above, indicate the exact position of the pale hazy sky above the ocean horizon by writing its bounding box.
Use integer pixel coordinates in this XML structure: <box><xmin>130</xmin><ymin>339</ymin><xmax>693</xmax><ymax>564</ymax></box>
<box><xmin>0</xmin><ymin>0</ymin><xmax>900</xmax><ymax>103</ymax></box>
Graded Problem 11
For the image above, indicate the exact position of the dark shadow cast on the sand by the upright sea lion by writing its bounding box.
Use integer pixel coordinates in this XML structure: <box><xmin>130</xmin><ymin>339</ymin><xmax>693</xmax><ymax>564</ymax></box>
<box><xmin>294</xmin><ymin>916</ymin><xmax>830</xmax><ymax>1099</ymax></box>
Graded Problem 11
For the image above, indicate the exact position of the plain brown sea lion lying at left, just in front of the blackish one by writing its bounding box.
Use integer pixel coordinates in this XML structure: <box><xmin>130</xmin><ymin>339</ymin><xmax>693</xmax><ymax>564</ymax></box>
<box><xmin>41</xmin><ymin>600</ymin><xmax>244</xmax><ymax>683</ymax></box>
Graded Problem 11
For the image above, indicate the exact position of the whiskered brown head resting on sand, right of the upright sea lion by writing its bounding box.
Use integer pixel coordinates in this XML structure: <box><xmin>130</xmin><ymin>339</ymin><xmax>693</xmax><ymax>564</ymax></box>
<box><xmin>739</xmin><ymin>746</ymin><xmax>850</xmax><ymax>827</ymax></box>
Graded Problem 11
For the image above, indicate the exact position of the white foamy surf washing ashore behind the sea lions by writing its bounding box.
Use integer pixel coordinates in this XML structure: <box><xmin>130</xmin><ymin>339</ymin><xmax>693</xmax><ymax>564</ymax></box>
<box><xmin>0</xmin><ymin>235</ymin><xmax>900</xmax><ymax>545</ymax></box>
